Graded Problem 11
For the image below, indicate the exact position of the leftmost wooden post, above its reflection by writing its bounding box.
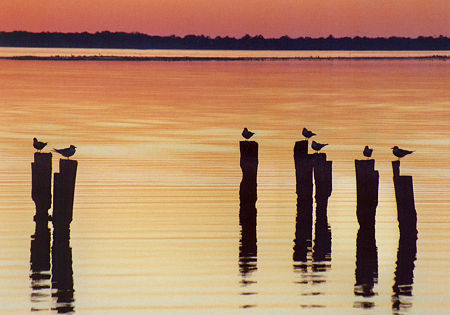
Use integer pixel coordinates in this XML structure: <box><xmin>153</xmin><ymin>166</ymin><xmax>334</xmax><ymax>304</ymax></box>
<box><xmin>31</xmin><ymin>152</ymin><xmax>52</xmax><ymax>222</ymax></box>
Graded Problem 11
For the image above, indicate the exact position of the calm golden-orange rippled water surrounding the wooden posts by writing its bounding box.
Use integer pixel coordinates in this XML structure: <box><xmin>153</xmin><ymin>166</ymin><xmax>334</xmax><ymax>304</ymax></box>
<box><xmin>0</xmin><ymin>50</ymin><xmax>450</xmax><ymax>314</ymax></box>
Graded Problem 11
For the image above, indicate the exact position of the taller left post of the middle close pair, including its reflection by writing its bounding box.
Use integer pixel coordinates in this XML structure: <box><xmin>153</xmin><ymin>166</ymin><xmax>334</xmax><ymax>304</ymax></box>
<box><xmin>293</xmin><ymin>140</ymin><xmax>313</xmax><ymax>262</ymax></box>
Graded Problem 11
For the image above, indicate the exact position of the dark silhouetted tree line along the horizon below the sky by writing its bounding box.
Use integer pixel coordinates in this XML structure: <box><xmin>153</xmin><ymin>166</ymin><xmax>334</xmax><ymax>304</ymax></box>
<box><xmin>0</xmin><ymin>31</ymin><xmax>450</xmax><ymax>50</ymax></box>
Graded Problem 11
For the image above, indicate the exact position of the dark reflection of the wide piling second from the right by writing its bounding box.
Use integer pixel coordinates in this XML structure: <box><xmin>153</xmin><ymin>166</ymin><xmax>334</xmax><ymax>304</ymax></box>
<box><xmin>354</xmin><ymin>228</ymin><xmax>378</xmax><ymax>302</ymax></box>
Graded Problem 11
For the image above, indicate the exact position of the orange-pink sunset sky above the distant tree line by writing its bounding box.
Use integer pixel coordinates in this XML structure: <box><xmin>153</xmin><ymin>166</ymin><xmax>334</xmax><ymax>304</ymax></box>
<box><xmin>0</xmin><ymin>0</ymin><xmax>450</xmax><ymax>37</ymax></box>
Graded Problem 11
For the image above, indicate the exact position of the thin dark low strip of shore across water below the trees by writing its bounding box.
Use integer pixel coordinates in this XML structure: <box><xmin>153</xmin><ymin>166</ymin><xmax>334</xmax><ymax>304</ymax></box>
<box><xmin>0</xmin><ymin>55</ymin><xmax>449</xmax><ymax>61</ymax></box>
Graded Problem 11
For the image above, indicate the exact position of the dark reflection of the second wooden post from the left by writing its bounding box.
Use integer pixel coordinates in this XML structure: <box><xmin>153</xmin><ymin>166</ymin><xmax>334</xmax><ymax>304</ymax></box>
<box><xmin>52</xmin><ymin>228</ymin><xmax>75</xmax><ymax>313</ymax></box>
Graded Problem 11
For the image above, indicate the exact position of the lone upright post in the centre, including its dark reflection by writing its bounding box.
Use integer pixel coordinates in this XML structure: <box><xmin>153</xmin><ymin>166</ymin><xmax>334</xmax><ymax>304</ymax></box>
<box><xmin>239</xmin><ymin>141</ymin><xmax>258</xmax><ymax>281</ymax></box>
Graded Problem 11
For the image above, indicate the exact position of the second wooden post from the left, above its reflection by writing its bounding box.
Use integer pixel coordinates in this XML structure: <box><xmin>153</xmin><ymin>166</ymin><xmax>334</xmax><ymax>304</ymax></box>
<box><xmin>53</xmin><ymin>159</ymin><xmax>78</xmax><ymax>229</ymax></box>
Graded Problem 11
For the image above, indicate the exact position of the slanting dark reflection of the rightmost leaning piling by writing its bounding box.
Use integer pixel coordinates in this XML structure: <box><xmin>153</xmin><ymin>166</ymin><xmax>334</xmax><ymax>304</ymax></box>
<box><xmin>392</xmin><ymin>233</ymin><xmax>417</xmax><ymax>311</ymax></box>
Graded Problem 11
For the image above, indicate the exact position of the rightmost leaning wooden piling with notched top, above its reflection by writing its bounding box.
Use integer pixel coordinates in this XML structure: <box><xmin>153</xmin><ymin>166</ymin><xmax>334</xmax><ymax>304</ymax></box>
<box><xmin>392</xmin><ymin>161</ymin><xmax>417</xmax><ymax>239</ymax></box>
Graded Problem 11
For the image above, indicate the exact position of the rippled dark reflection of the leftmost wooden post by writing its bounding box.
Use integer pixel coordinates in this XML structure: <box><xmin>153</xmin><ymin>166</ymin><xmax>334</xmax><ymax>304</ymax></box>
<box><xmin>30</xmin><ymin>221</ymin><xmax>51</xmax><ymax>311</ymax></box>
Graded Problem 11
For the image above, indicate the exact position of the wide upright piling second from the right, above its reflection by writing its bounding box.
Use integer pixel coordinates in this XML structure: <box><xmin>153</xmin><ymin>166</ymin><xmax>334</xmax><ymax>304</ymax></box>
<box><xmin>355</xmin><ymin>159</ymin><xmax>379</xmax><ymax>229</ymax></box>
